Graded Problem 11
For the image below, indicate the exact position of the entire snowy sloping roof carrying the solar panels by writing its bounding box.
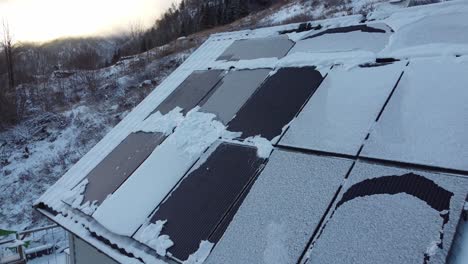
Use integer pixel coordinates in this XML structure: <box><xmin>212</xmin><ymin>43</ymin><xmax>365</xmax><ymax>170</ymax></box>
<box><xmin>35</xmin><ymin>1</ymin><xmax>468</xmax><ymax>263</ymax></box>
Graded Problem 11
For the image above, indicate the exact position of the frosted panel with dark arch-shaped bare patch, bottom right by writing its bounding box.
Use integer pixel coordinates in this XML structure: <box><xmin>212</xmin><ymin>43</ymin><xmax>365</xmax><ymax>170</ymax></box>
<box><xmin>307</xmin><ymin>162</ymin><xmax>468</xmax><ymax>264</ymax></box>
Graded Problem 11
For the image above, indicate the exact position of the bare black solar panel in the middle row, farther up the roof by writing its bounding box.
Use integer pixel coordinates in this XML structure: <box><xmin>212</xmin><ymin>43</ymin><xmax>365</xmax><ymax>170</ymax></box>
<box><xmin>228</xmin><ymin>67</ymin><xmax>323</xmax><ymax>140</ymax></box>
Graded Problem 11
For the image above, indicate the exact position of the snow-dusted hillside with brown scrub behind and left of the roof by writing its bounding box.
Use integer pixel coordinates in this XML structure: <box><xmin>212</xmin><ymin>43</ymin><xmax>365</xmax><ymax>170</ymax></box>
<box><xmin>0</xmin><ymin>0</ymin><xmax>442</xmax><ymax>230</ymax></box>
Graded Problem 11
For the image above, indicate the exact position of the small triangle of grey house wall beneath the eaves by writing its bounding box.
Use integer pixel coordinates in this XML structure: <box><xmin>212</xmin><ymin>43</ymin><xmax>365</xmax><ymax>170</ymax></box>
<box><xmin>68</xmin><ymin>234</ymin><xmax>118</xmax><ymax>264</ymax></box>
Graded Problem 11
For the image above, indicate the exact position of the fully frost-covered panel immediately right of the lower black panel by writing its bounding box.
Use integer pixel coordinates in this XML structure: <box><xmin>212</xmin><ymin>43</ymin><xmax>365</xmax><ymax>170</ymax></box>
<box><xmin>206</xmin><ymin>150</ymin><xmax>352</xmax><ymax>264</ymax></box>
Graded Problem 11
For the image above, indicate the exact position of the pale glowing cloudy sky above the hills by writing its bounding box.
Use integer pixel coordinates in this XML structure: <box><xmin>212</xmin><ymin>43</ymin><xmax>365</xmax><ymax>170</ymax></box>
<box><xmin>0</xmin><ymin>0</ymin><xmax>177</xmax><ymax>42</ymax></box>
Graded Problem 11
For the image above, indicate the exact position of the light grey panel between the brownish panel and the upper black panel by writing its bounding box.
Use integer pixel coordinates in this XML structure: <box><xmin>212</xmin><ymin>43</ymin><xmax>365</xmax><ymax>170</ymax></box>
<box><xmin>200</xmin><ymin>69</ymin><xmax>270</xmax><ymax>124</ymax></box>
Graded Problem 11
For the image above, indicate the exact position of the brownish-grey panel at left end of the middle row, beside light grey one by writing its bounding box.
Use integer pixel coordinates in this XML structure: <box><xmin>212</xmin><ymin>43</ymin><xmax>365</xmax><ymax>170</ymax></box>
<box><xmin>147</xmin><ymin>70</ymin><xmax>224</xmax><ymax>115</ymax></box>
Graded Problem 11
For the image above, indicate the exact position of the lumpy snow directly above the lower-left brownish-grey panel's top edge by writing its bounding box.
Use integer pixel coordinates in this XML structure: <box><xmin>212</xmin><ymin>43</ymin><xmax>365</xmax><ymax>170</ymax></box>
<box><xmin>133</xmin><ymin>107</ymin><xmax>184</xmax><ymax>135</ymax></box>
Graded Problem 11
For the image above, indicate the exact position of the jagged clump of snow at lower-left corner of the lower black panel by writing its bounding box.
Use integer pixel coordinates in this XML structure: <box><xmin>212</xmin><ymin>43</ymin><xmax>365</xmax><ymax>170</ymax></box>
<box><xmin>135</xmin><ymin>220</ymin><xmax>174</xmax><ymax>257</ymax></box>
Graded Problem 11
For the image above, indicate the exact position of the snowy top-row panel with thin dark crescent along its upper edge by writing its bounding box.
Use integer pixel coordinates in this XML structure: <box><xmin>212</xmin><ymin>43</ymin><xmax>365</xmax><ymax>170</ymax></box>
<box><xmin>289</xmin><ymin>23</ymin><xmax>392</xmax><ymax>54</ymax></box>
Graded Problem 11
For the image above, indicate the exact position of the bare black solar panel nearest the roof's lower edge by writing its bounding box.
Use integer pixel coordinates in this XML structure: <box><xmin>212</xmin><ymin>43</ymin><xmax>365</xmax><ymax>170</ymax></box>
<box><xmin>151</xmin><ymin>143</ymin><xmax>264</xmax><ymax>260</ymax></box>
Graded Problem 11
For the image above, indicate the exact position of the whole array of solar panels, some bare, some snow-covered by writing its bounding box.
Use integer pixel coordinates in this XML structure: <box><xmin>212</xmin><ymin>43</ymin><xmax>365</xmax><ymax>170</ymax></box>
<box><xmin>35</xmin><ymin>3</ymin><xmax>468</xmax><ymax>263</ymax></box>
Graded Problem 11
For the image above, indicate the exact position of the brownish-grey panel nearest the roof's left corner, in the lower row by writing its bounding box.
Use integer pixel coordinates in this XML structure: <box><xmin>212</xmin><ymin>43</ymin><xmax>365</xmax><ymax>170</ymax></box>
<box><xmin>83</xmin><ymin>132</ymin><xmax>166</xmax><ymax>203</ymax></box>
